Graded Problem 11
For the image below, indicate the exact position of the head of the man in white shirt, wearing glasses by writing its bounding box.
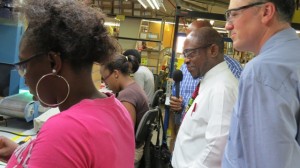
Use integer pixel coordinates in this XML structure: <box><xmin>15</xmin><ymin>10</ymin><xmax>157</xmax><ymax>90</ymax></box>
<box><xmin>183</xmin><ymin>27</ymin><xmax>224</xmax><ymax>78</ymax></box>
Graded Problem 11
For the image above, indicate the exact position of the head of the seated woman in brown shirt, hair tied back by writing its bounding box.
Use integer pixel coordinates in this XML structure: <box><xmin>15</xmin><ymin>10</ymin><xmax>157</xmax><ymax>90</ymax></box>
<box><xmin>100</xmin><ymin>55</ymin><xmax>139</xmax><ymax>93</ymax></box>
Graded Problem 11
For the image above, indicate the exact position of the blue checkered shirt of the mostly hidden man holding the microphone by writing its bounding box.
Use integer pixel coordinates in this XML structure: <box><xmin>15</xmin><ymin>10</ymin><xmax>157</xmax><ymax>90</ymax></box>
<box><xmin>172</xmin><ymin>55</ymin><xmax>243</xmax><ymax>121</ymax></box>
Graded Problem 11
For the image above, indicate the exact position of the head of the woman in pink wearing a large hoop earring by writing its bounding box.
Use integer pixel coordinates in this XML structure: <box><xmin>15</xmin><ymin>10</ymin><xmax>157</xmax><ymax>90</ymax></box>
<box><xmin>17</xmin><ymin>0</ymin><xmax>116</xmax><ymax>111</ymax></box>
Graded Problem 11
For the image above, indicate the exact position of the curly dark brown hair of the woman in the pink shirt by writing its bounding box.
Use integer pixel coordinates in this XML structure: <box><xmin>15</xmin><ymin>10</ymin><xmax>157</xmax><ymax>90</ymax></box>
<box><xmin>21</xmin><ymin>0</ymin><xmax>118</xmax><ymax>70</ymax></box>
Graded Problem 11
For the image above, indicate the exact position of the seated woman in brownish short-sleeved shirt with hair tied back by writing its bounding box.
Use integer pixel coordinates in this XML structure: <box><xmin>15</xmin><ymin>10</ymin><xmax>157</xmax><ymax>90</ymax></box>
<box><xmin>100</xmin><ymin>55</ymin><xmax>149</xmax><ymax>165</ymax></box>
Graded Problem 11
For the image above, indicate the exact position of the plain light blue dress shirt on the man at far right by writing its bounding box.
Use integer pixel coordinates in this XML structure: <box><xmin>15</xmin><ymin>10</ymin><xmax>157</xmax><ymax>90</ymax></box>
<box><xmin>222</xmin><ymin>28</ymin><xmax>300</xmax><ymax>168</ymax></box>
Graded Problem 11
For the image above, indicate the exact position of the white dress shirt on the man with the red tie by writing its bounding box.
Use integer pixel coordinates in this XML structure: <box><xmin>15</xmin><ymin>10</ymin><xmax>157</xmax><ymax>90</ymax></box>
<box><xmin>172</xmin><ymin>61</ymin><xmax>238</xmax><ymax>168</ymax></box>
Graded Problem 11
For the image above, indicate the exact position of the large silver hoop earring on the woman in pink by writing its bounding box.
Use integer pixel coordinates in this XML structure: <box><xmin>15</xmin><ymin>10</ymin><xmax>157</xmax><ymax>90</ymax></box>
<box><xmin>35</xmin><ymin>73</ymin><xmax>70</xmax><ymax>107</ymax></box>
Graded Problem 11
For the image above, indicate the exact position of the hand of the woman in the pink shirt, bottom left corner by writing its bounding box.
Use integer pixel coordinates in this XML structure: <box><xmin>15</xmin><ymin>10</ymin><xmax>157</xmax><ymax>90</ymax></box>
<box><xmin>0</xmin><ymin>136</ymin><xmax>18</xmax><ymax>162</ymax></box>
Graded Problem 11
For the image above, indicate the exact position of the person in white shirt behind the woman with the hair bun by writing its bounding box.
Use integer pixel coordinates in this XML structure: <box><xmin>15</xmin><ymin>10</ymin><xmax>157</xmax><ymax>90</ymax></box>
<box><xmin>123</xmin><ymin>49</ymin><xmax>154</xmax><ymax>103</ymax></box>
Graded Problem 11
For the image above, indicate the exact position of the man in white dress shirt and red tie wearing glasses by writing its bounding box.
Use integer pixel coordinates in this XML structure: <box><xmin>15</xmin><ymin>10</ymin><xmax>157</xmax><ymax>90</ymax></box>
<box><xmin>172</xmin><ymin>27</ymin><xmax>238</xmax><ymax>168</ymax></box>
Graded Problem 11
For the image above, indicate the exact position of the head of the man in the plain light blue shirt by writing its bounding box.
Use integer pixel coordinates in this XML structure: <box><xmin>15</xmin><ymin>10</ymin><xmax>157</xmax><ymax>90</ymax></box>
<box><xmin>225</xmin><ymin>0</ymin><xmax>295</xmax><ymax>54</ymax></box>
